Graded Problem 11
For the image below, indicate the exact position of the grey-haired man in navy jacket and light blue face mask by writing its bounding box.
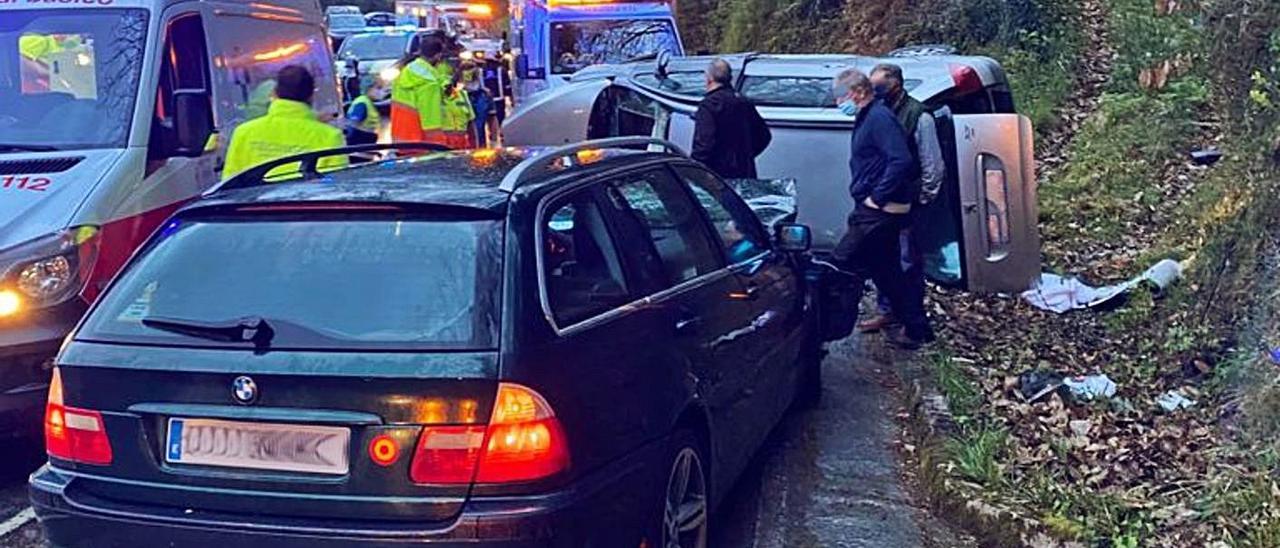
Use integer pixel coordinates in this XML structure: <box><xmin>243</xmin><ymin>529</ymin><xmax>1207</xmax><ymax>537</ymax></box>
<box><xmin>832</xmin><ymin>69</ymin><xmax>933</xmax><ymax>350</ymax></box>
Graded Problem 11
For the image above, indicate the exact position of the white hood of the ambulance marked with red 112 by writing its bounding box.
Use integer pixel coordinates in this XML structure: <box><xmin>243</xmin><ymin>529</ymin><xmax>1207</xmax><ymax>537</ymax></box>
<box><xmin>0</xmin><ymin>150</ymin><xmax>123</xmax><ymax>250</ymax></box>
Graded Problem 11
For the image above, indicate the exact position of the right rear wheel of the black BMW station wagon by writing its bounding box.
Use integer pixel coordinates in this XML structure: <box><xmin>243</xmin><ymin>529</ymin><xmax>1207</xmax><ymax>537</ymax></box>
<box><xmin>655</xmin><ymin>430</ymin><xmax>710</xmax><ymax>548</ymax></box>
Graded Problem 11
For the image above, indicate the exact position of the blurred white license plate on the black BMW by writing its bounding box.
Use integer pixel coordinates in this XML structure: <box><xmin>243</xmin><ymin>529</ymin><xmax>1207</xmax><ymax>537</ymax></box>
<box><xmin>165</xmin><ymin>419</ymin><xmax>351</xmax><ymax>475</ymax></box>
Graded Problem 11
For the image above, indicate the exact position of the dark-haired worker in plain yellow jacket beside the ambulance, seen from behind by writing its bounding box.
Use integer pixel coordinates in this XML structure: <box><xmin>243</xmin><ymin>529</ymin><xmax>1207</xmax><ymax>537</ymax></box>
<box><xmin>223</xmin><ymin>65</ymin><xmax>347</xmax><ymax>181</ymax></box>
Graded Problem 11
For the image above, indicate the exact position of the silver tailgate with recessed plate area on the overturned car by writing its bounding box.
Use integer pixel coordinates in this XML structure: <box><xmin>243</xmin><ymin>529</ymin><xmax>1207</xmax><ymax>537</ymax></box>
<box><xmin>955</xmin><ymin>114</ymin><xmax>1041</xmax><ymax>292</ymax></box>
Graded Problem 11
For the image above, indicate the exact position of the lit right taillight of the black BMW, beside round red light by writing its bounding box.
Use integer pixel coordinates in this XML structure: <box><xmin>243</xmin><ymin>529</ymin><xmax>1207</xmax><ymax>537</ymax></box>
<box><xmin>410</xmin><ymin>383</ymin><xmax>570</xmax><ymax>484</ymax></box>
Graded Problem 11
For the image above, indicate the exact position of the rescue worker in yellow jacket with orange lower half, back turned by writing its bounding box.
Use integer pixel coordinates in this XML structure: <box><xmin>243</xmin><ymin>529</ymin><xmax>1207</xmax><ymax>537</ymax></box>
<box><xmin>392</xmin><ymin>37</ymin><xmax>452</xmax><ymax>146</ymax></box>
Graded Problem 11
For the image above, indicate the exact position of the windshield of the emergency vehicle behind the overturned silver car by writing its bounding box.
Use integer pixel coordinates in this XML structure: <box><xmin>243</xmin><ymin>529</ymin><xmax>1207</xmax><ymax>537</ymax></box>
<box><xmin>550</xmin><ymin>19</ymin><xmax>680</xmax><ymax>74</ymax></box>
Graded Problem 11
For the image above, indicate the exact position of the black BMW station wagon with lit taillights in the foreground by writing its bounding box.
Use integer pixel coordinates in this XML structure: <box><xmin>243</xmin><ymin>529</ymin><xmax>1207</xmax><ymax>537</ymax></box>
<box><xmin>31</xmin><ymin>138</ymin><xmax>822</xmax><ymax>548</ymax></box>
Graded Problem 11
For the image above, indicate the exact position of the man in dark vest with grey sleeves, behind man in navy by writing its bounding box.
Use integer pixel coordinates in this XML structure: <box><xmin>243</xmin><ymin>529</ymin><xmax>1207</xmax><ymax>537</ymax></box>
<box><xmin>858</xmin><ymin>64</ymin><xmax>946</xmax><ymax>333</ymax></box>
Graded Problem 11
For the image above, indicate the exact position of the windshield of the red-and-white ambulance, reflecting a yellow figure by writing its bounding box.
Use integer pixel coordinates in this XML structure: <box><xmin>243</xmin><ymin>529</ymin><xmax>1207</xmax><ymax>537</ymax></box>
<box><xmin>0</xmin><ymin>9</ymin><xmax>147</xmax><ymax>149</ymax></box>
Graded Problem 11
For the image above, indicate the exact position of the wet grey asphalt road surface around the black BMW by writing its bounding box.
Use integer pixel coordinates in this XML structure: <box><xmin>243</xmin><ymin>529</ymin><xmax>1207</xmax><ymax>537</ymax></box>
<box><xmin>0</xmin><ymin>339</ymin><xmax>969</xmax><ymax>548</ymax></box>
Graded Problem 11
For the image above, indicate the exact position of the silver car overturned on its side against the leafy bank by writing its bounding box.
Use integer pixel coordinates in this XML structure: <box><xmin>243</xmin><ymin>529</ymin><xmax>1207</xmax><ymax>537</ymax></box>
<box><xmin>503</xmin><ymin>47</ymin><xmax>1039</xmax><ymax>292</ymax></box>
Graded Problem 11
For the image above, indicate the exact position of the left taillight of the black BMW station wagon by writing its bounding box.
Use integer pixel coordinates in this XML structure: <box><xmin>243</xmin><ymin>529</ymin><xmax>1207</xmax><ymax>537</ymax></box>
<box><xmin>45</xmin><ymin>369</ymin><xmax>111</xmax><ymax>465</ymax></box>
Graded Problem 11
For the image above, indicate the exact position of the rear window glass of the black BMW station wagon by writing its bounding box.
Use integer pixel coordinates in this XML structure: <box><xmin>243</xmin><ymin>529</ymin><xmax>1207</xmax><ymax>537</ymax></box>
<box><xmin>78</xmin><ymin>215</ymin><xmax>502</xmax><ymax>350</ymax></box>
